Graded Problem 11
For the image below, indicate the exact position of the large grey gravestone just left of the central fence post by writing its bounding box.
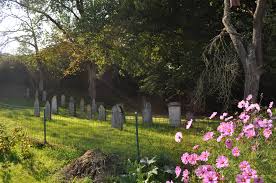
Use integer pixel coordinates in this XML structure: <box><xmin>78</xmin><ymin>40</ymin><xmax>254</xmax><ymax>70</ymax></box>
<box><xmin>111</xmin><ymin>104</ymin><xmax>125</xmax><ymax>130</ymax></box>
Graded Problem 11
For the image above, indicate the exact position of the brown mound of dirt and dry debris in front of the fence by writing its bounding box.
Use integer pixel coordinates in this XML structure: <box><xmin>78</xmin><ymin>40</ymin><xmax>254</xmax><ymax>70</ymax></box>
<box><xmin>63</xmin><ymin>150</ymin><xmax>119</xmax><ymax>183</ymax></box>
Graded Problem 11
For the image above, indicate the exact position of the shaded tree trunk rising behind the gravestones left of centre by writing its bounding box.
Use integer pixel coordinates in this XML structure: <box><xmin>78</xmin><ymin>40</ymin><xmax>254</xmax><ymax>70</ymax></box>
<box><xmin>87</xmin><ymin>63</ymin><xmax>96</xmax><ymax>100</ymax></box>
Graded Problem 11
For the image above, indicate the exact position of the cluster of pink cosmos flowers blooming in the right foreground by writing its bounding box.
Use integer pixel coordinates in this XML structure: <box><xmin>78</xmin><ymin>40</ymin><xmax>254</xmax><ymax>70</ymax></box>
<box><xmin>167</xmin><ymin>95</ymin><xmax>273</xmax><ymax>183</ymax></box>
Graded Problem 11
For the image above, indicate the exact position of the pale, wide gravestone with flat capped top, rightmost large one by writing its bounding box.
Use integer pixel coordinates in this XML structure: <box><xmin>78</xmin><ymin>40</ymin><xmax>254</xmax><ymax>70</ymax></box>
<box><xmin>168</xmin><ymin>102</ymin><xmax>181</xmax><ymax>127</ymax></box>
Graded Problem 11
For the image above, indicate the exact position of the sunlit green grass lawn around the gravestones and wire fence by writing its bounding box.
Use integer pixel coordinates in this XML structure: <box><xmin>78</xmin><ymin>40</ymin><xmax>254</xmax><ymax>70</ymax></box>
<box><xmin>0</xmin><ymin>100</ymin><xmax>217</xmax><ymax>182</ymax></box>
